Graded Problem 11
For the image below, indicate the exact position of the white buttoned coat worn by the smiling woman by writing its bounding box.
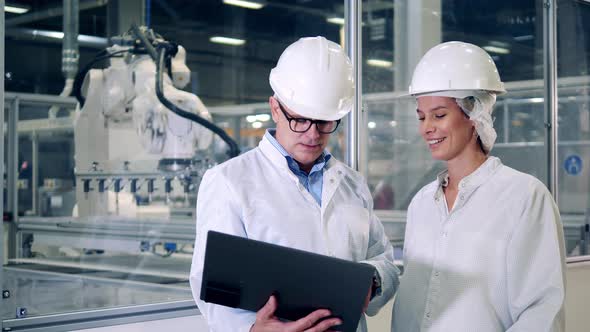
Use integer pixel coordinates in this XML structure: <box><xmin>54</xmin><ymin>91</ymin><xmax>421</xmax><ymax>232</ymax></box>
<box><xmin>392</xmin><ymin>157</ymin><xmax>565</xmax><ymax>332</ymax></box>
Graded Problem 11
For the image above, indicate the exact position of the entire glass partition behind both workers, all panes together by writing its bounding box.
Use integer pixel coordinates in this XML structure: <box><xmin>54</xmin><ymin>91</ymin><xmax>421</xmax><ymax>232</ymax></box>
<box><xmin>0</xmin><ymin>0</ymin><xmax>590</xmax><ymax>328</ymax></box>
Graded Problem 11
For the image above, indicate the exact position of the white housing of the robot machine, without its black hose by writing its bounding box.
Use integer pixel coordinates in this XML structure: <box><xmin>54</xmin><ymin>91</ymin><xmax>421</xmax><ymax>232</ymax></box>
<box><xmin>74</xmin><ymin>45</ymin><xmax>213</xmax><ymax>217</ymax></box>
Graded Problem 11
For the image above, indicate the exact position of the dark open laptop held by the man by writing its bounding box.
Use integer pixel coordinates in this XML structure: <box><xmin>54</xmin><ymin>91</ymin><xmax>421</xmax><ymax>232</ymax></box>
<box><xmin>201</xmin><ymin>231</ymin><xmax>375</xmax><ymax>332</ymax></box>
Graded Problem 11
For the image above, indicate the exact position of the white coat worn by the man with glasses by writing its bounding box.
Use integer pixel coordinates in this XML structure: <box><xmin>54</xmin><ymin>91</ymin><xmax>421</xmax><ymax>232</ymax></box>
<box><xmin>190</xmin><ymin>138</ymin><xmax>399</xmax><ymax>332</ymax></box>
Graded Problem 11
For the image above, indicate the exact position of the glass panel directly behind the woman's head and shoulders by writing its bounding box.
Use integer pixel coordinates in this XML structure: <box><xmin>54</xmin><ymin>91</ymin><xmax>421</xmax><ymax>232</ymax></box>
<box><xmin>363</xmin><ymin>0</ymin><xmax>547</xmax><ymax>252</ymax></box>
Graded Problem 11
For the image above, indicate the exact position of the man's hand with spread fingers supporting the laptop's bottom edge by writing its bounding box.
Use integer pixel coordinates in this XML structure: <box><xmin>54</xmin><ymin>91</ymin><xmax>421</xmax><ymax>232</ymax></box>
<box><xmin>250</xmin><ymin>295</ymin><xmax>342</xmax><ymax>332</ymax></box>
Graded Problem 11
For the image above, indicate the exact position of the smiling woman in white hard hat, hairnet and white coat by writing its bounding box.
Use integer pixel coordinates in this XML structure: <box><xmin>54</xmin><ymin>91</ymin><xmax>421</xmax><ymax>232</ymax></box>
<box><xmin>392</xmin><ymin>42</ymin><xmax>565</xmax><ymax>332</ymax></box>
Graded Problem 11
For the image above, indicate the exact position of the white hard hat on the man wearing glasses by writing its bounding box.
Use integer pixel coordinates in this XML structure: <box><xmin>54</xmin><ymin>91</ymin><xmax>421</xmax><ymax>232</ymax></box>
<box><xmin>269</xmin><ymin>37</ymin><xmax>354</xmax><ymax>121</ymax></box>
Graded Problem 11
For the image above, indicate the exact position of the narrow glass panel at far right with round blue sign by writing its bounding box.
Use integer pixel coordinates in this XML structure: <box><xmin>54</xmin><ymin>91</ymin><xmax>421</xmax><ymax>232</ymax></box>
<box><xmin>557</xmin><ymin>0</ymin><xmax>590</xmax><ymax>256</ymax></box>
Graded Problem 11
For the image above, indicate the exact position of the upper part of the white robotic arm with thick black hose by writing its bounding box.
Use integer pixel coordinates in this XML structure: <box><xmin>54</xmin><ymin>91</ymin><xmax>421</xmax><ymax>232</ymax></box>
<box><xmin>74</xmin><ymin>26</ymin><xmax>239</xmax><ymax>165</ymax></box>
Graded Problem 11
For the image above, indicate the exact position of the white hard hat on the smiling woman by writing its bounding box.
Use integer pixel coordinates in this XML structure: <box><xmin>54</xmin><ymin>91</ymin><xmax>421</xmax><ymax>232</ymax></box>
<box><xmin>409</xmin><ymin>41</ymin><xmax>506</xmax><ymax>97</ymax></box>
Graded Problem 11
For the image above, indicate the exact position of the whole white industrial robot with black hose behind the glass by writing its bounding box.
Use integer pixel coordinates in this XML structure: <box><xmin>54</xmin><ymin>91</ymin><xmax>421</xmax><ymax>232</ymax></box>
<box><xmin>74</xmin><ymin>26</ymin><xmax>238</xmax><ymax>217</ymax></box>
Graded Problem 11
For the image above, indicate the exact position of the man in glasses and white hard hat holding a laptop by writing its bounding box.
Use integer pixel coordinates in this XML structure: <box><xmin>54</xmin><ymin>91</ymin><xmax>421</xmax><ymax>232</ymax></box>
<box><xmin>190</xmin><ymin>37</ymin><xmax>398</xmax><ymax>332</ymax></box>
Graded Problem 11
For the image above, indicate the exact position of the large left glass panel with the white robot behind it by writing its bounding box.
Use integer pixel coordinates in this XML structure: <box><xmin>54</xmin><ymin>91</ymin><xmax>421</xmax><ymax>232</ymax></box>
<box><xmin>0</xmin><ymin>0</ymin><xmax>346</xmax><ymax>318</ymax></box>
